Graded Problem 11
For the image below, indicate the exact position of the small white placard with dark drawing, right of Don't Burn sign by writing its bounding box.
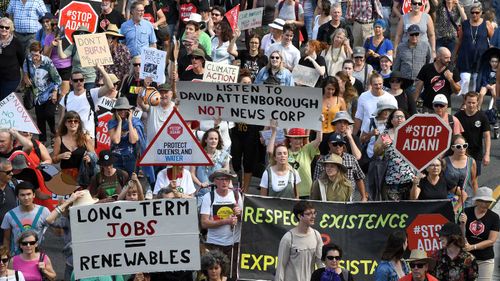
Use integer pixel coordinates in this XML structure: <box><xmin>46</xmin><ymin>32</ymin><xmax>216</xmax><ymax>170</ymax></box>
<box><xmin>139</xmin><ymin>48</ymin><xmax>167</xmax><ymax>84</ymax></box>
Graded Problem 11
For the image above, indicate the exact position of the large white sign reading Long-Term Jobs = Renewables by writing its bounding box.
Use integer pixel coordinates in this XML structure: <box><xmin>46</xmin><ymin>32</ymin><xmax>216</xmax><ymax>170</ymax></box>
<box><xmin>70</xmin><ymin>199</ymin><xmax>200</xmax><ymax>279</ymax></box>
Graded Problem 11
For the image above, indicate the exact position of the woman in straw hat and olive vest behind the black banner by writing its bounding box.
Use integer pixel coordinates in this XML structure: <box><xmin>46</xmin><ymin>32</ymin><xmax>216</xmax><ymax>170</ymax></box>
<box><xmin>311</xmin><ymin>153</ymin><xmax>352</xmax><ymax>202</ymax></box>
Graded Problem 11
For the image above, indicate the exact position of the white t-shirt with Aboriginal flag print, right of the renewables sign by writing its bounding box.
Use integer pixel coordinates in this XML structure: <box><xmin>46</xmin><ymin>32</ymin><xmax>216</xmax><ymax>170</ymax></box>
<box><xmin>200</xmin><ymin>190</ymin><xmax>243</xmax><ymax>246</ymax></box>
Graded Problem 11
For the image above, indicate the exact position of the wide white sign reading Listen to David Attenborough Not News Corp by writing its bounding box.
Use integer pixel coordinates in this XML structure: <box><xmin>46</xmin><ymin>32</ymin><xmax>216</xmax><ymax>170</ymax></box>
<box><xmin>177</xmin><ymin>81</ymin><xmax>323</xmax><ymax>130</ymax></box>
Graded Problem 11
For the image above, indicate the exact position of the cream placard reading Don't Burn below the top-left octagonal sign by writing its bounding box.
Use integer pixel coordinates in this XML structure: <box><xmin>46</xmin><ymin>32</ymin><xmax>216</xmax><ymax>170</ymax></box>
<box><xmin>74</xmin><ymin>33</ymin><xmax>113</xmax><ymax>67</ymax></box>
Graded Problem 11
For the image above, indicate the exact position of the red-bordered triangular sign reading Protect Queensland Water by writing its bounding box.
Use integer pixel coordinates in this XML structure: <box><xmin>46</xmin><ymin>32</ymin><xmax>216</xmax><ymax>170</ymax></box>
<box><xmin>139</xmin><ymin>108</ymin><xmax>213</xmax><ymax>166</ymax></box>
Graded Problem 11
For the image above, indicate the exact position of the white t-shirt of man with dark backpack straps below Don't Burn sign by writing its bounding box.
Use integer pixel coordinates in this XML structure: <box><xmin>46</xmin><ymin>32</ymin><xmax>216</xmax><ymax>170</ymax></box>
<box><xmin>59</xmin><ymin>88</ymin><xmax>99</xmax><ymax>138</ymax></box>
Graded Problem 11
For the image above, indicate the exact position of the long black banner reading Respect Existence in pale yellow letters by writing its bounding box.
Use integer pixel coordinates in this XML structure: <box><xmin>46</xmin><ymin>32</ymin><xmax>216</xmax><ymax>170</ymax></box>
<box><xmin>239</xmin><ymin>195</ymin><xmax>454</xmax><ymax>281</ymax></box>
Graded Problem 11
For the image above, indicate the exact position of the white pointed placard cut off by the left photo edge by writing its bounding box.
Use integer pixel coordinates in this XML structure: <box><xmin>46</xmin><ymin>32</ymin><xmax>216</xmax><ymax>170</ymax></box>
<box><xmin>0</xmin><ymin>93</ymin><xmax>40</xmax><ymax>134</ymax></box>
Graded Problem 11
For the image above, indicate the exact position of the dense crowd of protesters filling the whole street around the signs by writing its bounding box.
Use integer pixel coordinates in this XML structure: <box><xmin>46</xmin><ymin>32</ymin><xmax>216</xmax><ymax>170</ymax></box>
<box><xmin>0</xmin><ymin>0</ymin><xmax>500</xmax><ymax>281</ymax></box>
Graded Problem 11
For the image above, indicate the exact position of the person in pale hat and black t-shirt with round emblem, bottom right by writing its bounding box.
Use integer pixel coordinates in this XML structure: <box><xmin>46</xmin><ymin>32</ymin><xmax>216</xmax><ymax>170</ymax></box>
<box><xmin>459</xmin><ymin>186</ymin><xmax>500</xmax><ymax>280</ymax></box>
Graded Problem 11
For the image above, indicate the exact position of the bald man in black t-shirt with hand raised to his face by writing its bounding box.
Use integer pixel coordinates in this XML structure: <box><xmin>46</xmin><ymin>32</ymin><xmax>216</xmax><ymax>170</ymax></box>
<box><xmin>414</xmin><ymin>47</ymin><xmax>460</xmax><ymax>112</ymax></box>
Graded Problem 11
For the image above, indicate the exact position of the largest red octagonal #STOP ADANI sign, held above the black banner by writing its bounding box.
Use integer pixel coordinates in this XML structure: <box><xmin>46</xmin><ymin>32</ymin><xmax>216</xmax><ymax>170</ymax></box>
<box><xmin>395</xmin><ymin>114</ymin><xmax>452</xmax><ymax>171</ymax></box>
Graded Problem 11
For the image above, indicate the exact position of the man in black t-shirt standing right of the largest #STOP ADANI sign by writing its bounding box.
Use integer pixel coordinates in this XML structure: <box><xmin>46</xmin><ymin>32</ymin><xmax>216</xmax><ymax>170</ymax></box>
<box><xmin>455</xmin><ymin>92</ymin><xmax>491</xmax><ymax>176</ymax></box>
